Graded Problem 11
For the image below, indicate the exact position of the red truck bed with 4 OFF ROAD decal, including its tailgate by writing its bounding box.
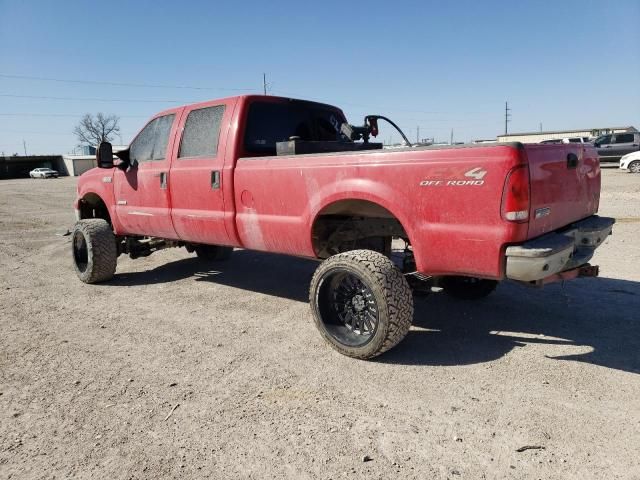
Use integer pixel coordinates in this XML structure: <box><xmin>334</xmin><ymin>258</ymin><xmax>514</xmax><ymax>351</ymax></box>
<box><xmin>234</xmin><ymin>143</ymin><xmax>600</xmax><ymax>279</ymax></box>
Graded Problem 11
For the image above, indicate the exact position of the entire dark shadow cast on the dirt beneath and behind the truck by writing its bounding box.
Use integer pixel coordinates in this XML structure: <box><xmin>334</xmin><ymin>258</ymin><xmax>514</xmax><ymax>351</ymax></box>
<box><xmin>110</xmin><ymin>250</ymin><xmax>640</xmax><ymax>373</ymax></box>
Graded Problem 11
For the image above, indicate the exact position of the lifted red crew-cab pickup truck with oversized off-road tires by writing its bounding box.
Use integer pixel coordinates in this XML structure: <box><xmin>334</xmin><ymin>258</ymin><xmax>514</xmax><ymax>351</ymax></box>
<box><xmin>72</xmin><ymin>95</ymin><xmax>614</xmax><ymax>358</ymax></box>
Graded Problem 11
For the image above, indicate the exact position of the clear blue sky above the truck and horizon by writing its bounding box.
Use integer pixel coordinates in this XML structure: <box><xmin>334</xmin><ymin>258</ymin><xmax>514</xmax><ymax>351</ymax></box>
<box><xmin>0</xmin><ymin>0</ymin><xmax>640</xmax><ymax>154</ymax></box>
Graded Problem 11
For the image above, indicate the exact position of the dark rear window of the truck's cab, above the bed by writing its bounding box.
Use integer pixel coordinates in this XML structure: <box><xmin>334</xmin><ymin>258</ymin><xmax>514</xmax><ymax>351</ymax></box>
<box><xmin>244</xmin><ymin>100</ymin><xmax>346</xmax><ymax>156</ymax></box>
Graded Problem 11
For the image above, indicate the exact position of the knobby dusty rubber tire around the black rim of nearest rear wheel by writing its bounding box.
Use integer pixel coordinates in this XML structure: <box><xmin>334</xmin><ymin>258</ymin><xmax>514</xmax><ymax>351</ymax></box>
<box><xmin>309</xmin><ymin>250</ymin><xmax>413</xmax><ymax>359</ymax></box>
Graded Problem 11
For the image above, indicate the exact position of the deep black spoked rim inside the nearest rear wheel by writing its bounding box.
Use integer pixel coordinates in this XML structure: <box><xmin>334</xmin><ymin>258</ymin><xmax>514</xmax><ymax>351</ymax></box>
<box><xmin>318</xmin><ymin>269</ymin><xmax>380</xmax><ymax>347</ymax></box>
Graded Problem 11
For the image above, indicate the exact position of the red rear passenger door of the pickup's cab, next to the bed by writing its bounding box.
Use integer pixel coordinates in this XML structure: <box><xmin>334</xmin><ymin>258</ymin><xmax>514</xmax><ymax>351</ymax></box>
<box><xmin>171</xmin><ymin>99</ymin><xmax>235</xmax><ymax>245</ymax></box>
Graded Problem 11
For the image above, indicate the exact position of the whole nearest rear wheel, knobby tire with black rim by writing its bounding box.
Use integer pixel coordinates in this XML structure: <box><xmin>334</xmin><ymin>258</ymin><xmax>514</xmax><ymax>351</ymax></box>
<box><xmin>309</xmin><ymin>250</ymin><xmax>413</xmax><ymax>359</ymax></box>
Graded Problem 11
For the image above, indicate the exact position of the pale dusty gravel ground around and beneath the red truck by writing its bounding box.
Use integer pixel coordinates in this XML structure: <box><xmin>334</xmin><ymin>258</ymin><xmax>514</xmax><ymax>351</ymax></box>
<box><xmin>0</xmin><ymin>169</ymin><xmax>640</xmax><ymax>480</ymax></box>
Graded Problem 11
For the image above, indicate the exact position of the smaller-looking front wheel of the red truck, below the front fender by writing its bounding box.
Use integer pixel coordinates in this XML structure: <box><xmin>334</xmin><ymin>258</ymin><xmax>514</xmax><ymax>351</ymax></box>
<box><xmin>71</xmin><ymin>218</ymin><xmax>118</xmax><ymax>283</ymax></box>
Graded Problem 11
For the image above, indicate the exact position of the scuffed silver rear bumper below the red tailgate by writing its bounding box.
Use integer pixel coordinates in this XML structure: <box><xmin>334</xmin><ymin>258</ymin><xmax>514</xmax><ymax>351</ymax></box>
<box><xmin>506</xmin><ymin>215</ymin><xmax>615</xmax><ymax>282</ymax></box>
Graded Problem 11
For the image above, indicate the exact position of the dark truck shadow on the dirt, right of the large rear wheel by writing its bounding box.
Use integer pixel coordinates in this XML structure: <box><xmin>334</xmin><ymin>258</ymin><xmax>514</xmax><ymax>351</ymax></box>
<box><xmin>378</xmin><ymin>277</ymin><xmax>640</xmax><ymax>373</ymax></box>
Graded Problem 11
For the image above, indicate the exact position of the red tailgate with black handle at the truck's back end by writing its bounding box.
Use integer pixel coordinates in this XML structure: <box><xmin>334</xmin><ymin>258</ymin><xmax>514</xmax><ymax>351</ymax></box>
<box><xmin>524</xmin><ymin>144</ymin><xmax>600</xmax><ymax>238</ymax></box>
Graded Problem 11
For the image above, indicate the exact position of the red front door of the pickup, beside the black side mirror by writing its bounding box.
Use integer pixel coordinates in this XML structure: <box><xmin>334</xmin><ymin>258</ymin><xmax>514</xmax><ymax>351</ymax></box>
<box><xmin>114</xmin><ymin>110</ymin><xmax>180</xmax><ymax>239</ymax></box>
